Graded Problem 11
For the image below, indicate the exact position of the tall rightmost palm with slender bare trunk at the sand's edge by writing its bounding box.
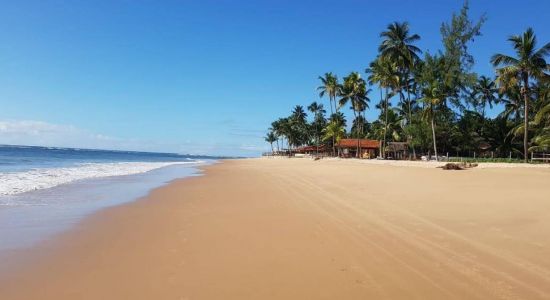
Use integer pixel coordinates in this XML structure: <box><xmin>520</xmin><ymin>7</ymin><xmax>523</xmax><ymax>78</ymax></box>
<box><xmin>491</xmin><ymin>28</ymin><xmax>550</xmax><ymax>162</ymax></box>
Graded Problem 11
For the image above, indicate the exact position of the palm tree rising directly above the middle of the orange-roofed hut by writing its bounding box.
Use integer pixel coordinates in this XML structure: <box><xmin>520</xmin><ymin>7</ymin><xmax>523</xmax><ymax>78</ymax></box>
<box><xmin>338</xmin><ymin>72</ymin><xmax>370</xmax><ymax>158</ymax></box>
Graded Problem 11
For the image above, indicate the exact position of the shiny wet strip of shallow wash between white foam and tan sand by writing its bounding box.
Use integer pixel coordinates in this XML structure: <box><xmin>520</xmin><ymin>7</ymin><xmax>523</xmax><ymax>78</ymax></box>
<box><xmin>0</xmin><ymin>162</ymin><xmax>209</xmax><ymax>260</ymax></box>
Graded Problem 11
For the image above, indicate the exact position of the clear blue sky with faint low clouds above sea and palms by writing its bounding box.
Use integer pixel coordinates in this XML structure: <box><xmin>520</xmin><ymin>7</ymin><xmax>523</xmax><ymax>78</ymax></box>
<box><xmin>0</xmin><ymin>0</ymin><xmax>550</xmax><ymax>156</ymax></box>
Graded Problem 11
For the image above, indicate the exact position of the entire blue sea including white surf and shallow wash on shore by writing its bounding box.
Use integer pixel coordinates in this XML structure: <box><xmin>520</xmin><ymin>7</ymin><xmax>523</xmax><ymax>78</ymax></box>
<box><xmin>0</xmin><ymin>146</ymin><xmax>215</xmax><ymax>253</ymax></box>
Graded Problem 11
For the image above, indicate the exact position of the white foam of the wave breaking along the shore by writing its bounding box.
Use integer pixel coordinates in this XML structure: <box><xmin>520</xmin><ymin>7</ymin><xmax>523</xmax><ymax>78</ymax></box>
<box><xmin>0</xmin><ymin>162</ymin><xmax>198</xmax><ymax>196</ymax></box>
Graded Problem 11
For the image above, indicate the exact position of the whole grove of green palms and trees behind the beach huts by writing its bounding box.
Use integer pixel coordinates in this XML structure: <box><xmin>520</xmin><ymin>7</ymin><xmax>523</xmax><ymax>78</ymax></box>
<box><xmin>266</xmin><ymin>4</ymin><xmax>550</xmax><ymax>161</ymax></box>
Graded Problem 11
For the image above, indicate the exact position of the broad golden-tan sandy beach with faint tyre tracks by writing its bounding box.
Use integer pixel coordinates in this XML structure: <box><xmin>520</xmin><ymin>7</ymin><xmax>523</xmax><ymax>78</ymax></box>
<box><xmin>0</xmin><ymin>159</ymin><xmax>550</xmax><ymax>300</ymax></box>
